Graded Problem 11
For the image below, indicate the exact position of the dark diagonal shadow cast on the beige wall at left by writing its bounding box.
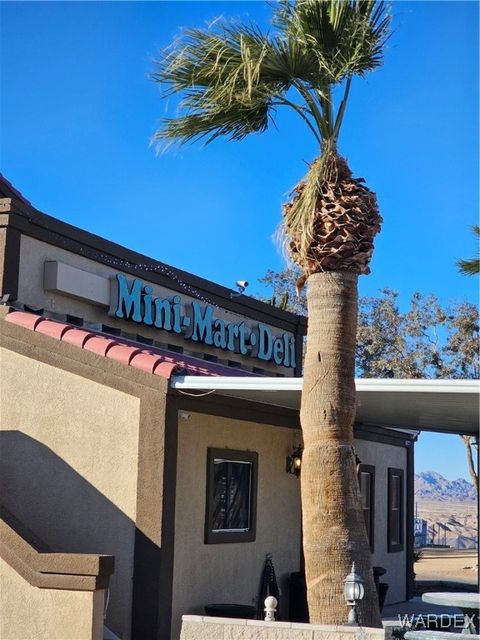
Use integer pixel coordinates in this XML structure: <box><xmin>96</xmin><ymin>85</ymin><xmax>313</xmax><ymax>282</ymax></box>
<box><xmin>0</xmin><ymin>430</ymin><xmax>161</xmax><ymax>639</ymax></box>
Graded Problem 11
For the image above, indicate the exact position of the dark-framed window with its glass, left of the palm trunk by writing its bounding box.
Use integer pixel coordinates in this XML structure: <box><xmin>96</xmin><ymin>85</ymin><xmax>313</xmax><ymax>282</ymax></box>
<box><xmin>205</xmin><ymin>448</ymin><xmax>258</xmax><ymax>544</ymax></box>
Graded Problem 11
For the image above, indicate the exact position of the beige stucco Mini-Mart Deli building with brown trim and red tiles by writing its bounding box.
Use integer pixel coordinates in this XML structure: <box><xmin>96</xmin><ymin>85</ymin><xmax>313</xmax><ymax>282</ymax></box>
<box><xmin>0</xmin><ymin>180</ymin><xmax>414</xmax><ymax>640</ymax></box>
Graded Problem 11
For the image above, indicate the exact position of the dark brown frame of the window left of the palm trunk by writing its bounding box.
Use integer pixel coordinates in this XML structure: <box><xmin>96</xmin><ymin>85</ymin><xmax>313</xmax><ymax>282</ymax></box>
<box><xmin>205</xmin><ymin>447</ymin><xmax>258</xmax><ymax>544</ymax></box>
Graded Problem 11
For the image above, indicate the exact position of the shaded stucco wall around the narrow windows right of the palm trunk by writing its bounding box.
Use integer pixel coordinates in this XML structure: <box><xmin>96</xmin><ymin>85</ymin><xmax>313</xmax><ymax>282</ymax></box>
<box><xmin>355</xmin><ymin>440</ymin><xmax>406</xmax><ymax>604</ymax></box>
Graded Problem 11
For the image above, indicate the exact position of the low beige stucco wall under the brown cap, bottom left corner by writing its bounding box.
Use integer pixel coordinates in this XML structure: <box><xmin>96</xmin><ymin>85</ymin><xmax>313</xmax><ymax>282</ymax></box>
<box><xmin>0</xmin><ymin>559</ymin><xmax>105</xmax><ymax>640</ymax></box>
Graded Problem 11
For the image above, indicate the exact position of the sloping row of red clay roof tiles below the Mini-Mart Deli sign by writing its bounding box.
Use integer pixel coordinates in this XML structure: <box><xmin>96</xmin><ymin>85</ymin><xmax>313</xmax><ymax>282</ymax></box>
<box><xmin>5</xmin><ymin>311</ymin><xmax>255</xmax><ymax>379</ymax></box>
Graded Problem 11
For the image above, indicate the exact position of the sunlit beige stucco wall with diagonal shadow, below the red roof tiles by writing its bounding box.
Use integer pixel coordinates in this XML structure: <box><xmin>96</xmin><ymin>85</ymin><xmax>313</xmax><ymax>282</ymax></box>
<box><xmin>0</xmin><ymin>349</ymin><xmax>140</xmax><ymax>638</ymax></box>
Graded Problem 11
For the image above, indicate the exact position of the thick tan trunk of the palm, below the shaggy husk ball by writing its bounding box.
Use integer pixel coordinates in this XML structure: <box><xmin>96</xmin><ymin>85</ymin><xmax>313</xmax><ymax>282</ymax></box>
<box><xmin>300</xmin><ymin>271</ymin><xmax>381</xmax><ymax>627</ymax></box>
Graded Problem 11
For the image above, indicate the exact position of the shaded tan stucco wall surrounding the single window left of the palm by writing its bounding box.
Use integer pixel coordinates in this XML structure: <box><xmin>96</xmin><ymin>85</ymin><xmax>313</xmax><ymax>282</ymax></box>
<box><xmin>172</xmin><ymin>413</ymin><xmax>301</xmax><ymax>638</ymax></box>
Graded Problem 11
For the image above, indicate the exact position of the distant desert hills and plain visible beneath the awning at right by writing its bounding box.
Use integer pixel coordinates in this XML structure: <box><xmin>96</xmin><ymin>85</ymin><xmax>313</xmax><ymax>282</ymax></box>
<box><xmin>415</xmin><ymin>471</ymin><xmax>478</xmax><ymax>549</ymax></box>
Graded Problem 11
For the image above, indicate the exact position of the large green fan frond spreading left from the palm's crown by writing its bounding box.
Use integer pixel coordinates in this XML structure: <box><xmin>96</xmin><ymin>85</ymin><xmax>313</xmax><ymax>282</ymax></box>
<box><xmin>153</xmin><ymin>22</ymin><xmax>304</xmax><ymax>143</ymax></box>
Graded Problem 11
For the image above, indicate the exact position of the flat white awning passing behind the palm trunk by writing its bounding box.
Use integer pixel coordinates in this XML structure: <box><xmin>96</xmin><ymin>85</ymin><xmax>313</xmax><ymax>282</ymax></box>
<box><xmin>171</xmin><ymin>376</ymin><xmax>480</xmax><ymax>435</ymax></box>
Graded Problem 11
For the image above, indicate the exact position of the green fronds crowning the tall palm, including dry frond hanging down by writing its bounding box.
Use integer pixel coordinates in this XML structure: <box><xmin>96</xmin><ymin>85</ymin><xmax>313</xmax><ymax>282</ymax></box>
<box><xmin>152</xmin><ymin>0</ymin><xmax>390</xmax><ymax>276</ymax></box>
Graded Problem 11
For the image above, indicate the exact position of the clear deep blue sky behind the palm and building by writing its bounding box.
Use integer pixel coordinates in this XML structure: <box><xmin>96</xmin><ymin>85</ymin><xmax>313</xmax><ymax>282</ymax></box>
<box><xmin>0</xmin><ymin>2</ymin><xmax>479</xmax><ymax>478</ymax></box>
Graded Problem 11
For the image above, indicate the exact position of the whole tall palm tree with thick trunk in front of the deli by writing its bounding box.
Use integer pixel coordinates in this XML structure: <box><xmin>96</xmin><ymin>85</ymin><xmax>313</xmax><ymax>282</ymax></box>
<box><xmin>153</xmin><ymin>0</ymin><xmax>389</xmax><ymax>626</ymax></box>
